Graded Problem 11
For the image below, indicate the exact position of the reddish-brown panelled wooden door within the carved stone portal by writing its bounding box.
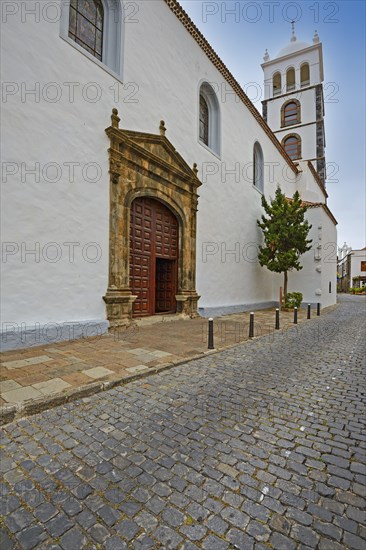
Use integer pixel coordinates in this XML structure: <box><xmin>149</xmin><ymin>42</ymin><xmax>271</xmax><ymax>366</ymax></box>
<box><xmin>130</xmin><ymin>198</ymin><xmax>179</xmax><ymax>317</ymax></box>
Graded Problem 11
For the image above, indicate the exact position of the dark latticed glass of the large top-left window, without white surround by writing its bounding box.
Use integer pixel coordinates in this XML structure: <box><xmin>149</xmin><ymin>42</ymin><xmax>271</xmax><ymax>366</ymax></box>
<box><xmin>69</xmin><ymin>0</ymin><xmax>104</xmax><ymax>61</ymax></box>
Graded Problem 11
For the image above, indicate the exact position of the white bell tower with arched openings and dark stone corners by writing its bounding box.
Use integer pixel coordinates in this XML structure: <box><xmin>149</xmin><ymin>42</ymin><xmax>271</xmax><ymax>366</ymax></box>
<box><xmin>262</xmin><ymin>22</ymin><xmax>326</xmax><ymax>185</ymax></box>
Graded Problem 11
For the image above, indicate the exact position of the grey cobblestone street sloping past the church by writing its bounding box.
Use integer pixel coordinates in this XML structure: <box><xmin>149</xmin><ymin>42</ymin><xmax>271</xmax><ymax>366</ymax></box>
<box><xmin>0</xmin><ymin>296</ymin><xmax>366</xmax><ymax>550</ymax></box>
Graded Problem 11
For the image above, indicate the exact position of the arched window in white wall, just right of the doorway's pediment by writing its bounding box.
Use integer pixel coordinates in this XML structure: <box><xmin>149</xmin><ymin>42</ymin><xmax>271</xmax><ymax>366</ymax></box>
<box><xmin>198</xmin><ymin>82</ymin><xmax>221</xmax><ymax>155</ymax></box>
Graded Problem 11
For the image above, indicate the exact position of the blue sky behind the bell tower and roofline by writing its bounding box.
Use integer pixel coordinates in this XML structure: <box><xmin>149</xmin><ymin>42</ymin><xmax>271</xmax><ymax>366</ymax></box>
<box><xmin>180</xmin><ymin>0</ymin><xmax>366</xmax><ymax>249</ymax></box>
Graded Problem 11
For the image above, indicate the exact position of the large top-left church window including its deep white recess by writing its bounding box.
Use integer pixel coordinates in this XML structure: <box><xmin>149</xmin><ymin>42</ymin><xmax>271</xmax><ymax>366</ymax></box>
<box><xmin>60</xmin><ymin>0</ymin><xmax>124</xmax><ymax>76</ymax></box>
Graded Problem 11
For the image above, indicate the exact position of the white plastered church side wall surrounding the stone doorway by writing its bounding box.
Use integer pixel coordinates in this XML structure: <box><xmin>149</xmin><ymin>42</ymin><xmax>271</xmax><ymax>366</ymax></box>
<box><xmin>2</xmin><ymin>0</ymin><xmax>338</xmax><ymax>336</ymax></box>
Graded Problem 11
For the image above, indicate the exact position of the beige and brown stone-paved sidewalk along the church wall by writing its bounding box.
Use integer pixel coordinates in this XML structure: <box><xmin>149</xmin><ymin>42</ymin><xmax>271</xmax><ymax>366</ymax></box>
<box><xmin>0</xmin><ymin>308</ymin><xmax>316</xmax><ymax>420</ymax></box>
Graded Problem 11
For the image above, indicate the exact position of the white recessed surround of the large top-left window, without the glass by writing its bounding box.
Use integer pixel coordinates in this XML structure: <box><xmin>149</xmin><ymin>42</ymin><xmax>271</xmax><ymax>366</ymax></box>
<box><xmin>60</xmin><ymin>0</ymin><xmax>124</xmax><ymax>80</ymax></box>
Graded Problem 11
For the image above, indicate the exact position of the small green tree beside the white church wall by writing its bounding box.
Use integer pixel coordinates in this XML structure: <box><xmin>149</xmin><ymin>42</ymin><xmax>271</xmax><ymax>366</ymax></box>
<box><xmin>257</xmin><ymin>187</ymin><xmax>312</xmax><ymax>303</ymax></box>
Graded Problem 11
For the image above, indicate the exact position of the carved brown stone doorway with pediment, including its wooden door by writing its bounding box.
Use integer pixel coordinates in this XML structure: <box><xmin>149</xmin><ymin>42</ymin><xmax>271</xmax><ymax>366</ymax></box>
<box><xmin>103</xmin><ymin>109</ymin><xmax>201</xmax><ymax>327</ymax></box>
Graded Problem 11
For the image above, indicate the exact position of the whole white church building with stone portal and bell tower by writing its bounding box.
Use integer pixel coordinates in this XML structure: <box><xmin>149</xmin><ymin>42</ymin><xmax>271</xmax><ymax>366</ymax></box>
<box><xmin>2</xmin><ymin>0</ymin><xmax>337</xmax><ymax>340</ymax></box>
